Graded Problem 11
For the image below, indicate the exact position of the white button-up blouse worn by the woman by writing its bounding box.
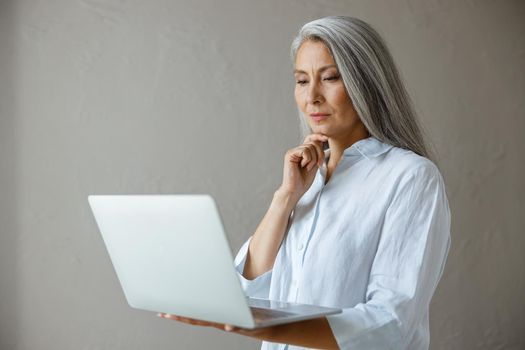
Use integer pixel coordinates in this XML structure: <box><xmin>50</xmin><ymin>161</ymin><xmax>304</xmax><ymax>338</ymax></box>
<box><xmin>235</xmin><ymin>137</ymin><xmax>450</xmax><ymax>350</ymax></box>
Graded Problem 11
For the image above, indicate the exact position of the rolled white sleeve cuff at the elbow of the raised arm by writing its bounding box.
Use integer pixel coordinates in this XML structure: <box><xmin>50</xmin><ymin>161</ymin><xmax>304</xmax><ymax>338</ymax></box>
<box><xmin>234</xmin><ymin>236</ymin><xmax>272</xmax><ymax>299</ymax></box>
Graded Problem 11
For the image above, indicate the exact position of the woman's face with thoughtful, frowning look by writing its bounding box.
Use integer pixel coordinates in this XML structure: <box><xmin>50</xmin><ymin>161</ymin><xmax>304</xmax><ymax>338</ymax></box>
<box><xmin>294</xmin><ymin>41</ymin><xmax>366</xmax><ymax>139</ymax></box>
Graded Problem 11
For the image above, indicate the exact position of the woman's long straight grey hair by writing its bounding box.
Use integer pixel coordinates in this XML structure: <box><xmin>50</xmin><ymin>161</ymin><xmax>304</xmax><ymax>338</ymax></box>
<box><xmin>290</xmin><ymin>16</ymin><xmax>434</xmax><ymax>159</ymax></box>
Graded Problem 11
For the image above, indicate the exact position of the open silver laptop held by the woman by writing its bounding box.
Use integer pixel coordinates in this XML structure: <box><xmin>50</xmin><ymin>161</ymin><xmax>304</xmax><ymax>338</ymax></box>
<box><xmin>88</xmin><ymin>195</ymin><xmax>341</xmax><ymax>329</ymax></box>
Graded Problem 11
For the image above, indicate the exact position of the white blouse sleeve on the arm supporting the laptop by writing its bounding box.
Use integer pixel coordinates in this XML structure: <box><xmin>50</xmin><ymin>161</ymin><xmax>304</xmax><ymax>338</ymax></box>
<box><xmin>327</xmin><ymin>163</ymin><xmax>450</xmax><ymax>349</ymax></box>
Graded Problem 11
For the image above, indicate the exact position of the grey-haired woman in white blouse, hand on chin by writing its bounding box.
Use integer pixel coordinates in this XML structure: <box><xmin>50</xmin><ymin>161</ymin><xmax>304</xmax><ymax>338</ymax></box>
<box><xmin>161</xmin><ymin>16</ymin><xmax>450</xmax><ymax>349</ymax></box>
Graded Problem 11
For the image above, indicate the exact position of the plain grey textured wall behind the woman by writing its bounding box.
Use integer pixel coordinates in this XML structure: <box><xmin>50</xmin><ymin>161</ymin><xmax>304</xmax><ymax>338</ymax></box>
<box><xmin>0</xmin><ymin>0</ymin><xmax>525</xmax><ymax>350</ymax></box>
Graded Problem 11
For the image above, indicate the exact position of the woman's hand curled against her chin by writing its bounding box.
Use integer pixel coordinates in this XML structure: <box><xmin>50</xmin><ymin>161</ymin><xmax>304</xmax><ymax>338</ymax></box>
<box><xmin>277</xmin><ymin>134</ymin><xmax>328</xmax><ymax>204</ymax></box>
